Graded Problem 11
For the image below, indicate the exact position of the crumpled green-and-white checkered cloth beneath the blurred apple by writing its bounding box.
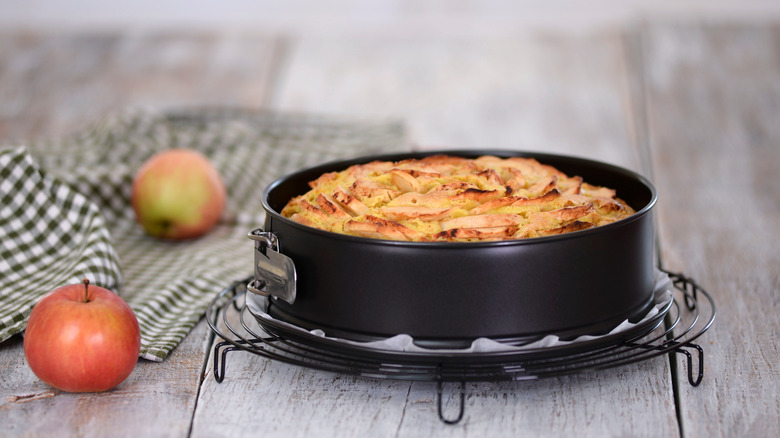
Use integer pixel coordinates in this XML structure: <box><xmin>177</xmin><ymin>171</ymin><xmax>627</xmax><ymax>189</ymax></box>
<box><xmin>0</xmin><ymin>109</ymin><xmax>409</xmax><ymax>361</ymax></box>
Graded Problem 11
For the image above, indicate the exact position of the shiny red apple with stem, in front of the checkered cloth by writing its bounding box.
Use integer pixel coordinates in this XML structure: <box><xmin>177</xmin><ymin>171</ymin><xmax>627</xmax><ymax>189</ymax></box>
<box><xmin>24</xmin><ymin>280</ymin><xmax>141</xmax><ymax>392</ymax></box>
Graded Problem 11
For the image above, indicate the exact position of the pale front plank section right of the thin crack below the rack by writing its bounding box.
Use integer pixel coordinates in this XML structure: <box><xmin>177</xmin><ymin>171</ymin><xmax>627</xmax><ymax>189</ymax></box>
<box><xmin>398</xmin><ymin>358</ymin><xmax>677</xmax><ymax>437</ymax></box>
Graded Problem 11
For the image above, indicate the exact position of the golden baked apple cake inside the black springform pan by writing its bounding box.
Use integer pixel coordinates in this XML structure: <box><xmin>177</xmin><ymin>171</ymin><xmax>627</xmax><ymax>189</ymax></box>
<box><xmin>281</xmin><ymin>155</ymin><xmax>635</xmax><ymax>242</ymax></box>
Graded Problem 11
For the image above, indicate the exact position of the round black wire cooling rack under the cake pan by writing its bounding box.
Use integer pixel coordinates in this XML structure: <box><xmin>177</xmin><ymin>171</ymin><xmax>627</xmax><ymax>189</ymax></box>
<box><xmin>206</xmin><ymin>272</ymin><xmax>716</xmax><ymax>424</ymax></box>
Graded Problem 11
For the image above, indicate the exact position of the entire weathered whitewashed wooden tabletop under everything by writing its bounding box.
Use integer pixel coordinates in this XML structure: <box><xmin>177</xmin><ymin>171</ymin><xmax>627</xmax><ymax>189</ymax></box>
<box><xmin>0</xmin><ymin>22</ymin><xmax>780</xmax><ymax>438</ymax></box>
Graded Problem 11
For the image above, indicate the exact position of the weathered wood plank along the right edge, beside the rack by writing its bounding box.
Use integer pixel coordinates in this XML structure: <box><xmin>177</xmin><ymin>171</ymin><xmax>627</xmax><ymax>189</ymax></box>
<box><xmin>634</xmin><ymin>23</ymin><xmax>780</xmax><ymax>437</ymax></box>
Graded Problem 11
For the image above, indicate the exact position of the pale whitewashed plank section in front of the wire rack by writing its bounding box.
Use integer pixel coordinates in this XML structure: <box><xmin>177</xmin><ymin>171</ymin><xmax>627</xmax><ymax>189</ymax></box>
<box><xmin>193</xmin><ymin>352</ymin><xmax>677</xmax><ymax>437</ymax></box>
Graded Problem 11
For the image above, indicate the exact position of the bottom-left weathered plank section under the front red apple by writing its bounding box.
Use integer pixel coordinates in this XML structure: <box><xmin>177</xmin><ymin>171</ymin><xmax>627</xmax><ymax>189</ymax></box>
<box><xmin>0</xmin><ymin>322</ymin><xmax>210</xmax><ymax>437</ymax></box>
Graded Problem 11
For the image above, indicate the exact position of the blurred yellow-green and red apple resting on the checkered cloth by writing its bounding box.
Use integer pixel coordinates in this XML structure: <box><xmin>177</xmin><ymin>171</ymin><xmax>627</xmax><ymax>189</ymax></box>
<box><xmin>131</xmin><ymin>149</ymin><xmax>226</xmax><ymax>240</ymax></box>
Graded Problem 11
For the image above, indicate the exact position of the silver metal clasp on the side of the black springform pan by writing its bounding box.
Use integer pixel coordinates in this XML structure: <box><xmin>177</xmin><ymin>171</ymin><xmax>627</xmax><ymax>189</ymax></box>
<box><xmin>247</xmin><ymin>228</ymin><xmax>297</xmax><ymax>304</ymax></box>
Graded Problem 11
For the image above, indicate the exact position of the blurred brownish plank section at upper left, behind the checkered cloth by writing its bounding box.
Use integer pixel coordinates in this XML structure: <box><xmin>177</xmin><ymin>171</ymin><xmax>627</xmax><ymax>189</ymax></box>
<box><xmin>0</xmin><ymin>33</ymin><xmax>278</xmax><ymax>141</ymax></box>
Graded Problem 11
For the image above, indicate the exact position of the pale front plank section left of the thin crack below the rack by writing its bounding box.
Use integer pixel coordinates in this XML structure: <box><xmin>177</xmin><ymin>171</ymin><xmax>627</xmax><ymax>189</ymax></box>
<box><xmin>193</xmin><ymin>352</ymin><xmax>409</xmax><ymax>437</ymax></box>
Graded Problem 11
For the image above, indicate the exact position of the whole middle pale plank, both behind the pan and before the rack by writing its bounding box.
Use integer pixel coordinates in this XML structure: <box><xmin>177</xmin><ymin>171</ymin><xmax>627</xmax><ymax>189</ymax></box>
<box><xmin>193</xmin><ymin>34</ymin><xmax>678</xmax><ymax>437</ymax></box>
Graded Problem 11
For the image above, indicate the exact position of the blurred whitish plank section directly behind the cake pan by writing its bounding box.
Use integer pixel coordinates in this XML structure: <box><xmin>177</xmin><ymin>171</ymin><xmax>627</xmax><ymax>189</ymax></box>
<box><xmin>272</xmin><ymin>33</ymin><xmax>638</xmax><ymax>167</ymax></box>
